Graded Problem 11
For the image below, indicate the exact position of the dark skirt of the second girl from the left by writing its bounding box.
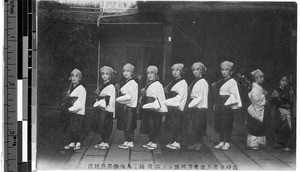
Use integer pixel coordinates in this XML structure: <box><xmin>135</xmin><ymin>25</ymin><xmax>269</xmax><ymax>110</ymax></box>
<box><xmin>93</xmin><ymin>108</ymin><xmax>113</xmax><ymax>136</ymax></box>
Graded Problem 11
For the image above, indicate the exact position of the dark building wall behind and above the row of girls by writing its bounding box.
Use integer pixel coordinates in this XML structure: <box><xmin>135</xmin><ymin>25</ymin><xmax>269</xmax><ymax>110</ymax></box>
<box><xmin>38</xmin><ymin>2</ymin><xmax>296</xmax><ymax>107</ymax></box>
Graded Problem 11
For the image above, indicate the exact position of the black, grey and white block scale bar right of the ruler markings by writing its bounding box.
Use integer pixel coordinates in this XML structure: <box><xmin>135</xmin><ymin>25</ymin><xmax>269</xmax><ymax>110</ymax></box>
<box><xmin>17</xmin><ymin>1</ymin><xmax>31</xmax><ymax>171</ymax></box>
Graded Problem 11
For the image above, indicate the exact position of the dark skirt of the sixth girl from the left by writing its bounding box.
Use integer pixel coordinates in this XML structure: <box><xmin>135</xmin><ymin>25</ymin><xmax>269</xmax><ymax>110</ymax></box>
<box><xmin>184</xmin><ymin>108</ymin><xmax>207</xmax><ymax>137</ymax></box>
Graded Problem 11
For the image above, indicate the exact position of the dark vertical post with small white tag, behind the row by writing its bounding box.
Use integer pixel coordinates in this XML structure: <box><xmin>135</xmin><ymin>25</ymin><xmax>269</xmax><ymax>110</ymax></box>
<box><xmin>162</xmin><ymin>23</ymin><xmax>173</xmax><ymax>82</ymax></box>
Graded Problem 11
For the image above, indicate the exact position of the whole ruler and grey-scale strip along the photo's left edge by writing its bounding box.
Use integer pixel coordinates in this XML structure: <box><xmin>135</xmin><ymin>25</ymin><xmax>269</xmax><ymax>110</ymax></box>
<box><xmin>4</xmin><ymin>0</ymin><xmax>36</xmax><ymax>172</ymax></box>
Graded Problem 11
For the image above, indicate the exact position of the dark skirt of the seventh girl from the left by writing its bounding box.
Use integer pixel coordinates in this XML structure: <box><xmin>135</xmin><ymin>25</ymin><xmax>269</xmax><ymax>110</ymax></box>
<box><xmin>214</xmin><ymin>96</ymin><xmax>233</xmax><ymax>133</ymax></box>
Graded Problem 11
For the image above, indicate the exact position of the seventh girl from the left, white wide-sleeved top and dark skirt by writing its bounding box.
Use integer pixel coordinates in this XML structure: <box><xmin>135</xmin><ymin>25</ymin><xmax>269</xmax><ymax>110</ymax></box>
<box><xmin>212</xmin><ymin>61</ymin><xmax>242</xmax><ymax>150</ymax></box>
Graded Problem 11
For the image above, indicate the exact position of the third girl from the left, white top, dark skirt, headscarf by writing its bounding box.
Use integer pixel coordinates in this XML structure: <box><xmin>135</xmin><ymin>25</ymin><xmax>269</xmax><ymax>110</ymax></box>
<box><xmin>116</xmin><ymin>63</ymin><xmax>138</xmax><ymax>149</ymax></box>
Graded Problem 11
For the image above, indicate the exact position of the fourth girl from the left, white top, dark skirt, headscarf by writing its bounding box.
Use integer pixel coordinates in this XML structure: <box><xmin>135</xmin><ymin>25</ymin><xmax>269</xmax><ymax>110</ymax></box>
<box><xmin>140</xmin><ymin>66</ymin><xmax>168</xmax><ymax>150</ymax></box>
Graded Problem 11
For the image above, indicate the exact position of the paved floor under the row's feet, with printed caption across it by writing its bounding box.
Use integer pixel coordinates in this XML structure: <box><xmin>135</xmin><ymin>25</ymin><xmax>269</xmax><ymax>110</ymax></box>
<box><xmin>37</xmin><ymin>112</ymin><xmax>296</xmax><ymax>170</ymax></box>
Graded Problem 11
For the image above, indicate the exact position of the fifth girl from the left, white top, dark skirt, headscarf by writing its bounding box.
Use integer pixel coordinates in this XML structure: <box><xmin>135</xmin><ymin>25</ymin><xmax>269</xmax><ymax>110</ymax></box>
<box><xmin>165</xmin><ymin>63</ymin><xmax>187</xmax><ymax>149</ymax></box>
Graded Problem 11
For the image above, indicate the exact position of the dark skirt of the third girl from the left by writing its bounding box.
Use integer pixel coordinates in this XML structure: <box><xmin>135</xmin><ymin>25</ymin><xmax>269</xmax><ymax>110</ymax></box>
<box><xmin>117</xmin><ymin>105</ymin><xmax>137</xmax><ymax>131</ymax></box>
